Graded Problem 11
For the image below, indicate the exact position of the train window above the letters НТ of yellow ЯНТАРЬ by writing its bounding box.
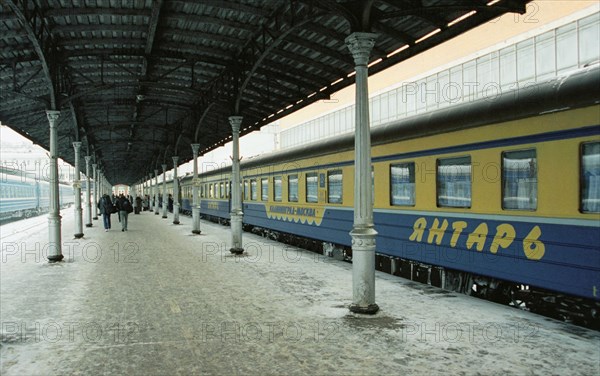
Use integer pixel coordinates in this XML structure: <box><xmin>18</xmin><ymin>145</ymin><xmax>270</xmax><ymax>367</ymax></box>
<box><xmin>437</xmin><ymin>157</ymin><xmax>471</xmax><ymax>208</ymax></box>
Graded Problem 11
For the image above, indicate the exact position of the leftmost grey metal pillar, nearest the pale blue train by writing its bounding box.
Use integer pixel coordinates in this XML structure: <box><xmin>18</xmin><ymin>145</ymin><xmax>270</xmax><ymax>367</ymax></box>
<box><xmin>46</xmin><ymin>110</ymin><xmax>64</xmax><ymax>262</ymax></box>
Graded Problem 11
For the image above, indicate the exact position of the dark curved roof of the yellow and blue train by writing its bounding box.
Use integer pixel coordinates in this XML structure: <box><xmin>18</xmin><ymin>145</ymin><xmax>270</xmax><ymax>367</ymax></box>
<box><xmin>200</xmin><ymin>64</ymin><xmax>600</xmax><ymax>176</ymax></box>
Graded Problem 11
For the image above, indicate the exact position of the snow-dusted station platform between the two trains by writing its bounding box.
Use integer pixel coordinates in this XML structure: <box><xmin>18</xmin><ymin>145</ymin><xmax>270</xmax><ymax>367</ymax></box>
<box><xmin>0</xmin><ymin>209</ymin><xmax>600</xmax><ymax>375</ymax></box>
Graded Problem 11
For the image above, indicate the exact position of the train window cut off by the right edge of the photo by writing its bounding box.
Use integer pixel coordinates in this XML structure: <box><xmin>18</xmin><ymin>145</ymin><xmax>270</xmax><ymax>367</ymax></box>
<box><xmin>580</xmin><ymin>142</ymin><xmax>600</xmax><ymax>213</ymax></box>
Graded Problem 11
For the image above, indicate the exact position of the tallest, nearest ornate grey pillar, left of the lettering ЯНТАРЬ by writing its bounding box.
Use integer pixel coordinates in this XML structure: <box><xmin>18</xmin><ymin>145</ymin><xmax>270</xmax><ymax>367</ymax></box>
<box><xmin>346</xmin><ymin>32</ymin><xmax>379</xmax><ymax>314</ymax></box>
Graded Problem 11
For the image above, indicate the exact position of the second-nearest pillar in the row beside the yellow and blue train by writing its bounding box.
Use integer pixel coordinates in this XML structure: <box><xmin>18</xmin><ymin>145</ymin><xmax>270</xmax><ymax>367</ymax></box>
<box><xmin>229</xmin><ymin>116</ymin><xmax>244</xmax><ymax>255</ymax></box>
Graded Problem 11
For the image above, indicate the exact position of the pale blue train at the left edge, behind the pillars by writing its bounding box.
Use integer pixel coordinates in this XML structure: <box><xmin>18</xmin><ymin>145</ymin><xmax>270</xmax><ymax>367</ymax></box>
<box><xmin>0</xmin><ymin>170</ymin><xmax>75</xmax><ymax>221</ymax></box>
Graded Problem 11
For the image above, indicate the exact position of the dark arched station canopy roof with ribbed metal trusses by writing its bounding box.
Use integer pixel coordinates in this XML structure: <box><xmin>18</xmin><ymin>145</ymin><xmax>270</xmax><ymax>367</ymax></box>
<box><xmin>0</xmin><ymin>0</ymin><xmax>530</xmax><ymax>184</ymax></box>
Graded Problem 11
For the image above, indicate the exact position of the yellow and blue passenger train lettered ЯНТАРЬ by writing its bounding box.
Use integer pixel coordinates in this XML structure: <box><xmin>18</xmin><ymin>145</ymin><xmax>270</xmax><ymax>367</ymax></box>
<box><xmin>151</xmin><ymin>65</ymin><xmax>600</xmax><ymax>327</ymax></box>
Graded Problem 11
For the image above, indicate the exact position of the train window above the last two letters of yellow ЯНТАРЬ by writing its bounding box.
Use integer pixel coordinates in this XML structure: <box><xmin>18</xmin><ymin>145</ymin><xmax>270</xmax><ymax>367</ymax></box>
<box><xmin>502</xmin><ymin>150</ymin><xmax>537</xmax><ymax>210</ymax></box>
